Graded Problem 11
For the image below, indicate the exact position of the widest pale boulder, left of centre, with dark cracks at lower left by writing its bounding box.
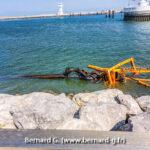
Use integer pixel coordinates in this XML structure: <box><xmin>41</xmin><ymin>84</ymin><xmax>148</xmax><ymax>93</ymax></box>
<box><xmin>10</xmin><ymin>93</ymin><xmax>78</xmax><ymax>129</ymax></box>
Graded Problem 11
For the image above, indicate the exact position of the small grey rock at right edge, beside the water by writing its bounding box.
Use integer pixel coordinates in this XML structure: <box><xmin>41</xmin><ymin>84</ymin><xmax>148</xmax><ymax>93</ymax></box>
<box><xmin>136</xmin><ymin>96</ymin><xmax>150</xmax><ymax>112</ymax></box>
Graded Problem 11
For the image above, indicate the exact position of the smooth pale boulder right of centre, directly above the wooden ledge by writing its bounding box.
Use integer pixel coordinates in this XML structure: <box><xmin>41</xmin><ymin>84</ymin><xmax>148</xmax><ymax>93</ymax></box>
<box><xmin>79</xmin><ymin>103</ymin><xmax>128</xmax><ymax>131</ymax></box>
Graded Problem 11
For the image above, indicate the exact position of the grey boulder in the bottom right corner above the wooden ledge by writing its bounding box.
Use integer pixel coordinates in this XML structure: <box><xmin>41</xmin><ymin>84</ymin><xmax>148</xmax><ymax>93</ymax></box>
<box><xmin>120</xmin><ymin>112</ymin><xmax>150</xmax><ymax>132</ymax></box>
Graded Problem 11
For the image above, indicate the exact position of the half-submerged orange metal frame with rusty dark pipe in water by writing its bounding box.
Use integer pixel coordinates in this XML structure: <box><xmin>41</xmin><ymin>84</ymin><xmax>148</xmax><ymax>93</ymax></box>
<box><xmin>19</xmin><ymin>58</ymin><xmax>150</xmax><ymax>87</ymax></box>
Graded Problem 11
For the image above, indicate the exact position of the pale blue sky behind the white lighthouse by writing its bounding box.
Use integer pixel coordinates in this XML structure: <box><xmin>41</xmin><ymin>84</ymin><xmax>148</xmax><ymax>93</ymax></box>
<box><xmin>0</xmin><ymin>0</ymin><xmax>129</xmax><ymax>16</ymax></box>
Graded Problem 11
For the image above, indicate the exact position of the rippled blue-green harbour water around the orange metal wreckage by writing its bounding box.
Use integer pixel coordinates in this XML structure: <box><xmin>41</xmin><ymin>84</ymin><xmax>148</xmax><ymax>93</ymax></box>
<box><xmin>0</xmin><ymin>15</ymin><xmax>150</xmax><ymax>96</ymax></box>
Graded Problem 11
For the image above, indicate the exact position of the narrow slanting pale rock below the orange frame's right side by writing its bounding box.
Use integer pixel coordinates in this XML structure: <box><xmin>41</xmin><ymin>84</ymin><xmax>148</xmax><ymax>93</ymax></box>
<box><xmin>116</xmin><ymin>94</ymin><xmax>142</xmax><ymax>114</ymax></box>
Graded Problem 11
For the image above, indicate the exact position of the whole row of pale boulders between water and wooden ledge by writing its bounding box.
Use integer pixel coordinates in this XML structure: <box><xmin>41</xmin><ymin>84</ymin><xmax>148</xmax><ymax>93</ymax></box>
<box><xmin>0</xmin><ymin>89</ymin><xmax>150</xmax><ymax>132</ymax></box>
